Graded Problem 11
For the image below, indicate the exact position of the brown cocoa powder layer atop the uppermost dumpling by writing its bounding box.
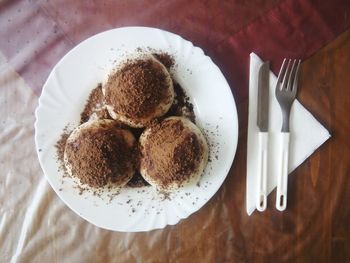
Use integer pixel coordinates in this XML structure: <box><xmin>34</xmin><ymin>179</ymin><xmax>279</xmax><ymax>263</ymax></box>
<box><xmin>105</xmin><ymin>59</ymin><xmax>170</xmax><ymax>118</ymax></box>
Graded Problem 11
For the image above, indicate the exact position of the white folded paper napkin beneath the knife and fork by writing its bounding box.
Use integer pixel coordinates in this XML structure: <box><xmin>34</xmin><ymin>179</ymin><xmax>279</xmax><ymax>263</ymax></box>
<box><xmin>246</xmin><ymin>53</ymin><xmax>330</xmax><ymax>215</ymax></box>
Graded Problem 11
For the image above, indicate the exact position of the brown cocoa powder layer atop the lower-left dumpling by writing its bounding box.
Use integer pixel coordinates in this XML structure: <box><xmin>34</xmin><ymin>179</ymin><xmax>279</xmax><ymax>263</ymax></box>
<box><xmin>66</xmin><ymin>126</ymin><xmax>134</xmax><ymax>188</ymax></box>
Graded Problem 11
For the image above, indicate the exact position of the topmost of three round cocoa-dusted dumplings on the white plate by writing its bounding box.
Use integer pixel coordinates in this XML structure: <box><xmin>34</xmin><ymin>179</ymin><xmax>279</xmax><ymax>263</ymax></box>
<box><xmin>102</xmin><ymin>55</ymin><xmax>174</xmax><ymax>128</ymax></box>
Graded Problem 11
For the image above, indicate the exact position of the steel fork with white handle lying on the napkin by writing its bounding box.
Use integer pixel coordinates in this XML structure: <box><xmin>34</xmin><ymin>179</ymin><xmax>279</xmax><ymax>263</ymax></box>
<box><xmin>276</xmin><ymin>59</ymin><xmax>300</xmax><ymax>211</ymax></box>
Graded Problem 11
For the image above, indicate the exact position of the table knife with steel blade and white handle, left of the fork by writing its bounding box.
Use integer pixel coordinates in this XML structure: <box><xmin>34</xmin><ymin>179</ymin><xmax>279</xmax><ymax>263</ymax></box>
<box><xmin>256</xmin><ymin>62</ymin><xmax>270</xmax><ymax>211</ymax></box>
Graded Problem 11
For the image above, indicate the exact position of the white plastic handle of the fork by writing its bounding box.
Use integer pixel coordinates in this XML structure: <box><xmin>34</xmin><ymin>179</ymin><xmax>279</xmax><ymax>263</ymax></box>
<box><xmin>276</xmin><ymin>132</ymin><xmax>290</xmax><ymax>211</ymax></box>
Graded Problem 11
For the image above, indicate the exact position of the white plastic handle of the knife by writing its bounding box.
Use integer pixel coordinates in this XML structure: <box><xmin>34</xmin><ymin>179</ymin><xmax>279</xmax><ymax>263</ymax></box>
<box><xmin>256</xmin><ymin>132</ymin><xmax>268</xmax><ymax>212</ymax></box>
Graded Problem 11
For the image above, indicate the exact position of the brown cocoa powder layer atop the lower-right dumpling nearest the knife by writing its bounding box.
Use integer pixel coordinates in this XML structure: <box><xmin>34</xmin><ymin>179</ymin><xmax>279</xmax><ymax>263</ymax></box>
<box><xmin>143</xmin><ymin>120</ymin><xmax>201</xmax><ymax>187</ymax></box>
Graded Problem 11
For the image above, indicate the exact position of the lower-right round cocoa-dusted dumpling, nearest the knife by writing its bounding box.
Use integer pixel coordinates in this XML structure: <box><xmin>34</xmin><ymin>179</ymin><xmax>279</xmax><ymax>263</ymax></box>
<box><xmin>140</xmin><ymin>117</ymin><xmax>208</xmax><ymax>190</ymax></box>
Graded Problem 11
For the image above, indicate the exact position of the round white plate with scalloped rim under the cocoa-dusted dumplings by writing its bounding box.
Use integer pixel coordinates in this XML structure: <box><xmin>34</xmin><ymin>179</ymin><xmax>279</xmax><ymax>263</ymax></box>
<box><xmin>35</xmin><ymin>27</ymin><xmax>238</xmax><ymax>232</ymax></box>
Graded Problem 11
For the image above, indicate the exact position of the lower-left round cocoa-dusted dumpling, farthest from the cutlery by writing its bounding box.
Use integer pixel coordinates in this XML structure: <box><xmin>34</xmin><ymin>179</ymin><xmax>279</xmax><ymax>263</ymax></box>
<box><xmin>64</xmin><ymin>120</ymin><xmax>136</xmax><ymax>188</ymax></box>
